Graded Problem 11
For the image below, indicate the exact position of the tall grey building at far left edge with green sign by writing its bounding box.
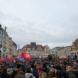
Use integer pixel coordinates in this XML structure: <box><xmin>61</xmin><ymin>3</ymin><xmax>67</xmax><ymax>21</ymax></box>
<box><xmin>0</xmin><ymin>25</ymin><xmax>9</xmax><ymax>58</ymax></box>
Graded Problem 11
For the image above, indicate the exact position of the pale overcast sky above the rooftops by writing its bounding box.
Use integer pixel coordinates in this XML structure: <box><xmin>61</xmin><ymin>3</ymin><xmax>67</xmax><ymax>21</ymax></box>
<box><xmin>0</xmin><ymin>0</ymin><xmax>78</xmax><ymax>48</ymax></box>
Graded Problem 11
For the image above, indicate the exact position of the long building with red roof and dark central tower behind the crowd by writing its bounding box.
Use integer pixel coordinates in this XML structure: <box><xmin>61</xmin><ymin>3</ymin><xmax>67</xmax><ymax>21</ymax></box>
<box><xmin>21</xmin><ymin>42</ymin><xmax>51</xmax><ymax>57</ymax></box>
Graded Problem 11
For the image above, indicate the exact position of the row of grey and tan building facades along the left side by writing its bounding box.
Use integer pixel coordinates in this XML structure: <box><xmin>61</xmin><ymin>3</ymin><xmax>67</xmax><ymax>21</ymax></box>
<box><xmin>0</xmin><ymin>25</ymin><xmax>17</xmax><ymax>58</ymax></box>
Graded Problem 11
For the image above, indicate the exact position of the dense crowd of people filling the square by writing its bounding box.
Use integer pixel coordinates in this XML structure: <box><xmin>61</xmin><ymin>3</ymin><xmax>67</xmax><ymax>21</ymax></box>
<box><xmin>0</xmin><ymin>55</ymin><xmax>78</xmax><ymax>78</ymax></box>
